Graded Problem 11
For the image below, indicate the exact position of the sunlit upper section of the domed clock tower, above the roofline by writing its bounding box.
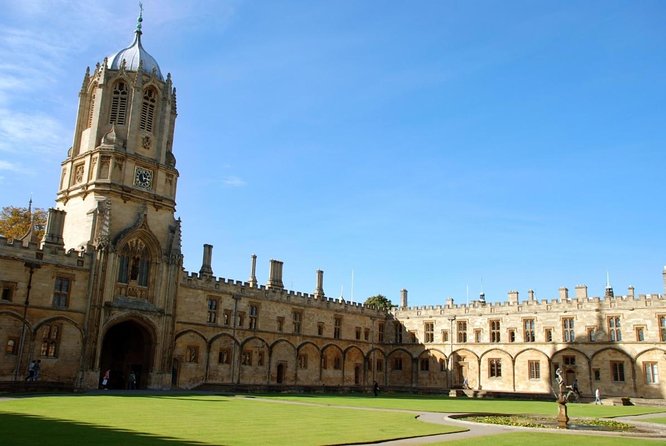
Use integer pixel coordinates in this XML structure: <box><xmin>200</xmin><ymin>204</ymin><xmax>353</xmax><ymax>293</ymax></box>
<box><xmin>56</xmin><ymin>12</ymin><xmax>178</xmax><ymax>250</ymax></box>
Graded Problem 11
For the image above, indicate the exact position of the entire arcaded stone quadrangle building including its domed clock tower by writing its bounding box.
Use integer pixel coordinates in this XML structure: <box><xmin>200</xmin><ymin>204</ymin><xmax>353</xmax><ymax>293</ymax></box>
<box><xmin>0</xmin><ymin>21</ymin><xmax>666</xmax><ymax>398</ymax></box>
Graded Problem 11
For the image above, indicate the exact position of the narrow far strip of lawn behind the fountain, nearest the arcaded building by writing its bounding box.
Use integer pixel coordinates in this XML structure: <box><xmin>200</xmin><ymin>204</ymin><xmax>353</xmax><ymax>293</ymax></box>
<box><xmin>261</xmin><ymin>394</ymin><xmax>666</xmax><ymax>418</ymax></box>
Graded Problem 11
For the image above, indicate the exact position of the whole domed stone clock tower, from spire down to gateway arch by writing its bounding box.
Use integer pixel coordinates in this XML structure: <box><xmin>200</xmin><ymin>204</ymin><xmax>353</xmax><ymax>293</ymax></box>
<box><xmin>56</xmin><ymin>11</ymin><xmax>182</xmax><ymax>388</ymax></box>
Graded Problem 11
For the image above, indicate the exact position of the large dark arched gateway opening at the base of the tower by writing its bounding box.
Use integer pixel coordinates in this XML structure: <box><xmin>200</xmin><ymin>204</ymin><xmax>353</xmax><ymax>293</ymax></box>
<box><xmin>100</xmin><ymin>321</ymin><xmax>155</xmax><ymax>389</ymax></box>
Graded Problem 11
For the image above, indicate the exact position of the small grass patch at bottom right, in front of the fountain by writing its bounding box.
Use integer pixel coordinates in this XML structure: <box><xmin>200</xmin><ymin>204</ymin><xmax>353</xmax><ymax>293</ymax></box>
<box><xmin>432</xmin><ymin>432</ymin><xmax>664</xmax><ymax>446</ymax></box>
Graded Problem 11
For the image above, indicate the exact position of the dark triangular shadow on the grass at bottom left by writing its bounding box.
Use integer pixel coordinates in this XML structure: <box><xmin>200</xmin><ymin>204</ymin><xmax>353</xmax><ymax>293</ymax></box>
<box><xmin>0</xmin><ymin>413</ymin><xmax>204</xmax><ymax>446</ymax></box>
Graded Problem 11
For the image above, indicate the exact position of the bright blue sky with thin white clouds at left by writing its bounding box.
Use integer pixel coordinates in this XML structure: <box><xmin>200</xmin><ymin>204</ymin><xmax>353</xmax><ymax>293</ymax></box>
<box><xmin>0</xmin><ymin>0</ymin><xmax>666</xmax><ymax>305</ymax></box>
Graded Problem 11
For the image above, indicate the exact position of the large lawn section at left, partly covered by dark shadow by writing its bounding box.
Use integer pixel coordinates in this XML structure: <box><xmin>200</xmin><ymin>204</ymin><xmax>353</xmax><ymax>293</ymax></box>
<box><xmin>0</xmin><ymin>395</ymin><xmax>459</xmax><ymax>446</ymax></box>
